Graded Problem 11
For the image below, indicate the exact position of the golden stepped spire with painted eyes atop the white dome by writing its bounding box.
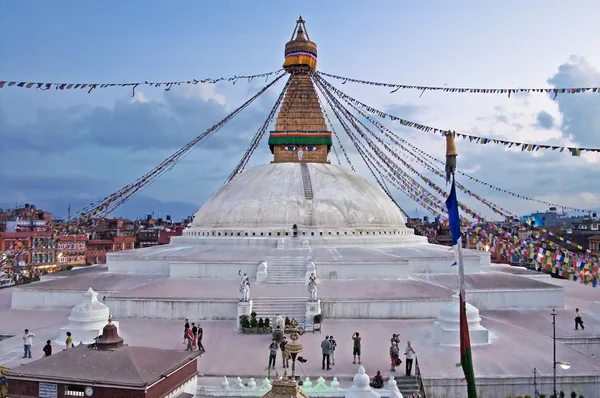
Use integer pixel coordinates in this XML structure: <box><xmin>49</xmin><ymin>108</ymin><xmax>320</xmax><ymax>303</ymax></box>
<box><xmin>269</xmin><ymin>17</ymin><xmax>333</xmax><ymax>163</ymax></box>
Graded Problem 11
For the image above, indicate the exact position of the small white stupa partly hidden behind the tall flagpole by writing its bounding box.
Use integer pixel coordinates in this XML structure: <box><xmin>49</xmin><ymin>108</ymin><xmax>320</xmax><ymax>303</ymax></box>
<box><xmin>433</xmin><ymin>294</ymin><xmax>490</xmax><ymax>346</ymax></box>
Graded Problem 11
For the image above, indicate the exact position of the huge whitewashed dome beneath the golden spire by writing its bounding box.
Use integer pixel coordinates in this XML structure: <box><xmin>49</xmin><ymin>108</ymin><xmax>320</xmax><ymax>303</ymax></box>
<box><xmin>186</xmin><ymin>163</ymin><xmax>413</xmax><ymax>236</ymax></box>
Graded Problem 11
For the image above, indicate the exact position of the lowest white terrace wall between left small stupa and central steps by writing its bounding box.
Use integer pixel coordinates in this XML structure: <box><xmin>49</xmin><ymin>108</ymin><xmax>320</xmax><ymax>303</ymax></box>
<box><xmin>105</xmin><ymin>297</ymin><xmax>238</xmax><ymax>320</ymax></box>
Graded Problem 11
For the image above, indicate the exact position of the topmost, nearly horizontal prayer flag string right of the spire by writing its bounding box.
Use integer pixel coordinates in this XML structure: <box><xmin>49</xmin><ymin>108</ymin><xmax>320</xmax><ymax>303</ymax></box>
<box><xmin>315</xmin><ymin>72</ymin><xmax>600</xmax><ymax>99</ymax></box>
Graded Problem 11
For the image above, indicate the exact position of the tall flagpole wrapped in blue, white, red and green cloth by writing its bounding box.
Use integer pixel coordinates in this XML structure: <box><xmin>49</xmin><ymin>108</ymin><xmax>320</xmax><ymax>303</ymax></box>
<box><xmin>446</xmin><ymin>131</ymin><xmax>477</xmax><ymax>398</ymax></box>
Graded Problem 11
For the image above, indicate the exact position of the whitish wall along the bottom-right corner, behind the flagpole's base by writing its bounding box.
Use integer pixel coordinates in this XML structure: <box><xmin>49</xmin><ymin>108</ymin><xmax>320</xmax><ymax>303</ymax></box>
<box><xmin>423</xmin><ymin>369</ymin><xmax>600</xmax><ymax>398</ymax></box>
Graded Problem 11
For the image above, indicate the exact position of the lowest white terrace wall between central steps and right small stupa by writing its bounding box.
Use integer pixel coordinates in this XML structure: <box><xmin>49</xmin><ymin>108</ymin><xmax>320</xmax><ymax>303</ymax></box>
<box><xmin>321</xmin><ymin>299</ymin><xmax>452</xmax><ymax>319</ymax></box>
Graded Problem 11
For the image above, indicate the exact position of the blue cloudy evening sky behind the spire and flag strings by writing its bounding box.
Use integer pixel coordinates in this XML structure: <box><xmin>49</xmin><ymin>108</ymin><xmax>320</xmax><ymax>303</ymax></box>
<box><xmin>0</xmin><ymin>0</ymin><xmax>600</xmax><ymax>218</ymax></box>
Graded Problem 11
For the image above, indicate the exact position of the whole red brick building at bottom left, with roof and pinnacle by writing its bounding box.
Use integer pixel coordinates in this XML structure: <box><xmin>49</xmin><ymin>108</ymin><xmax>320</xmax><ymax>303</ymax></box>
<box><xmin>4</xmin><ymin>320</ymin><xmax>199</xmax><ymax>398</ymax></box>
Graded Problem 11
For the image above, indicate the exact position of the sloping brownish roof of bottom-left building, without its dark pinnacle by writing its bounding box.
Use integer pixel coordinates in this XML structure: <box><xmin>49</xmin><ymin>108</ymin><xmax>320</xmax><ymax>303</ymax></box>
<box><xmin>4</xmin><ymin>344</ymin><xmax>199</xmax><ymax>388</ymax></box>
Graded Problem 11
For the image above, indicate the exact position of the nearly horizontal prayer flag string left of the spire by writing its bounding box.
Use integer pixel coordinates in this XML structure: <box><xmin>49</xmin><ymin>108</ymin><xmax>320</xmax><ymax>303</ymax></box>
<box><xmin>0</xmin><ymin>69</ymin><xmax>283</xmax><ymax>97</ymax></box>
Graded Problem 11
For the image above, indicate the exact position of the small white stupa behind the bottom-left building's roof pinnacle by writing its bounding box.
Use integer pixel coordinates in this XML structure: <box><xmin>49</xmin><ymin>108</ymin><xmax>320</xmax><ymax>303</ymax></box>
<box><xmin>54</xmin><ymin>287</ymin><xmax>119</xmax><ymax>346</ymax></box>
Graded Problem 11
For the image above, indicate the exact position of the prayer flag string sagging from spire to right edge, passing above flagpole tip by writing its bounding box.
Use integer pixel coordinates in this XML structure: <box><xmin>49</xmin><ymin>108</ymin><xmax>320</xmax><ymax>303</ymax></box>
<box><xmin>319</xmin><ymin>78</ymin><xmax>600</xmax><ymax>156</ymax></box>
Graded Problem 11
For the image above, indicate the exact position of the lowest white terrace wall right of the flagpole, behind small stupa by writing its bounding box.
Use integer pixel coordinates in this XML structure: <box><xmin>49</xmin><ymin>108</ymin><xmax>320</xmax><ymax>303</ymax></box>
<box><xmin>467</xmin><ymin>288</ymin><xmax>565</xmax><ymax>311</ymax></box>
